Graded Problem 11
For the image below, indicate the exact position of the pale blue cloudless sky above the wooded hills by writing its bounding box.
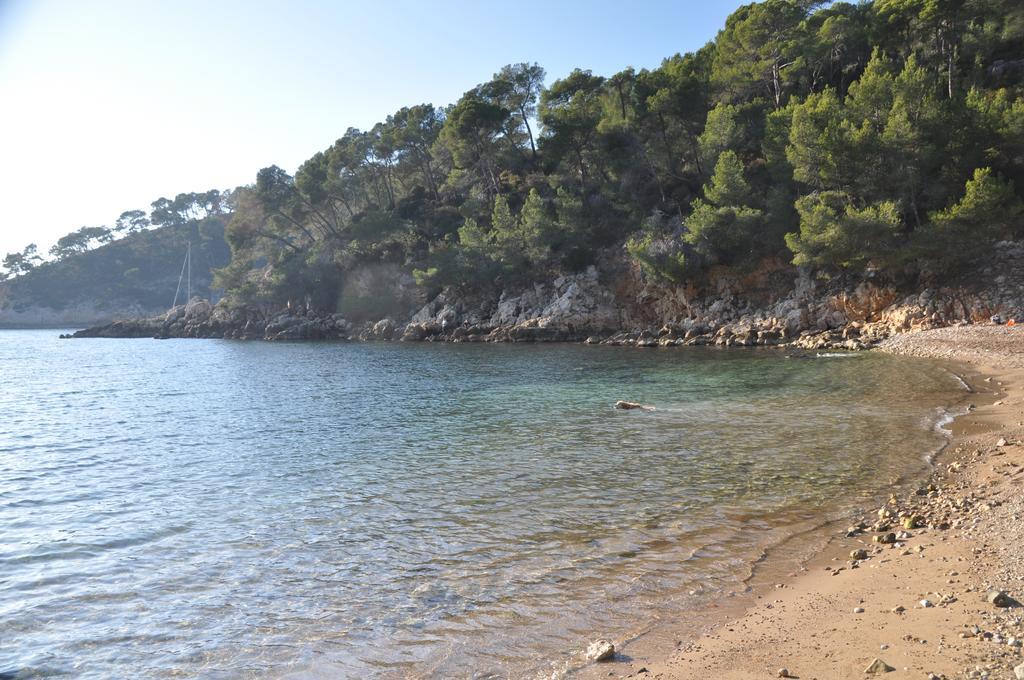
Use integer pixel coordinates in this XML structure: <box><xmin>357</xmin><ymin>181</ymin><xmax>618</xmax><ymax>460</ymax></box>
<box><xmin>0</xmin><ymin>0</ymin><xmax>741</xmax><ymax>256</ymax></box>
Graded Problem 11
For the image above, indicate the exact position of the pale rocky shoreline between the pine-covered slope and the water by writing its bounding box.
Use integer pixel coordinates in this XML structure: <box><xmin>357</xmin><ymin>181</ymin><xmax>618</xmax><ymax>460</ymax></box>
<box><xmin>66</xmin><ymin>242</ymin><xmax>1024</xmax><ymax>350</ymax></box>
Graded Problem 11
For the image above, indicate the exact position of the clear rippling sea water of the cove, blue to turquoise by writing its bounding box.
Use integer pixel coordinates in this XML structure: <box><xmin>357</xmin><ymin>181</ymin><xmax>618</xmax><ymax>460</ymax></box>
<box><xmin>0</xmin><ymin>331</ymin><xmax>963</xmax><ymax>678</ymax></box>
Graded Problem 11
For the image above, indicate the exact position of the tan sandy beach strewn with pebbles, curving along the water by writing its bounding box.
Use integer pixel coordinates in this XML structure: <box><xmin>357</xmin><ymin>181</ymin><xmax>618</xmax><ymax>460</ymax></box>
<box><xmin>581</xmin><ymin>326</ymin><xmax>1024</xmax><ymax>680</ymax></box>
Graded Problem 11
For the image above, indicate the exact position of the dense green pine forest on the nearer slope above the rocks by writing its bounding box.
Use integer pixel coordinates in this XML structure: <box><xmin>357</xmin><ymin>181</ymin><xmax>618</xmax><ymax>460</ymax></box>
<box><xmin>209</xmin><ymin>0</ymin><xmax>1024</xmax><ymax>307</ymax></box>
